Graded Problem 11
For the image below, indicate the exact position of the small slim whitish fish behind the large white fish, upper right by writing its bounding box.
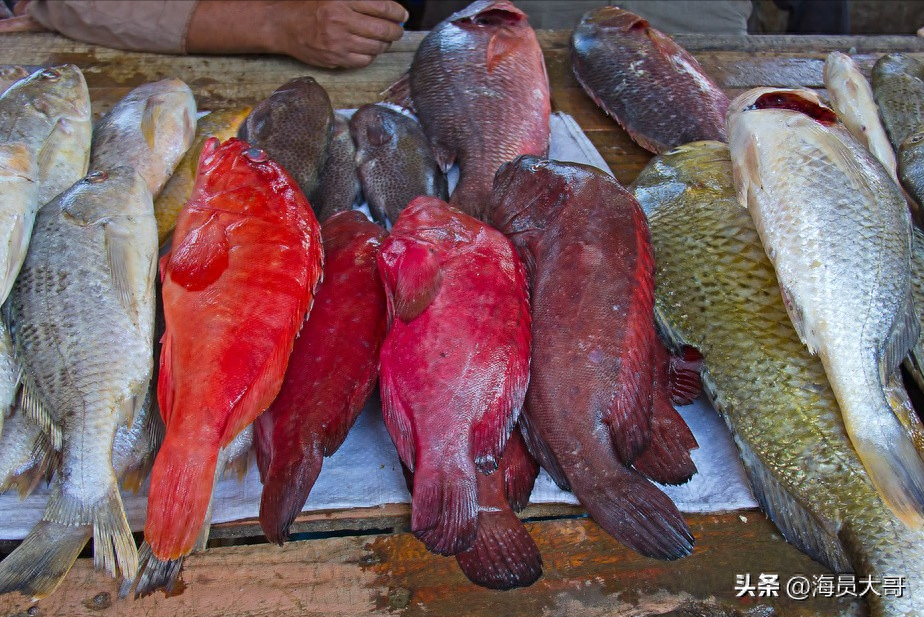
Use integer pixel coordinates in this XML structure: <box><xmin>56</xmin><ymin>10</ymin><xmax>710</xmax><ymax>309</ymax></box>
<box><xmin>824</xmin><ymin>51</ymin><xmax>898</xmax><ymax>182</ymax></box>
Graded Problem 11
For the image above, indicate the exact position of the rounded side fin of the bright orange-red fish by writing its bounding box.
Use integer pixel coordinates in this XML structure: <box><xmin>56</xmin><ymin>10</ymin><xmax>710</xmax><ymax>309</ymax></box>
<box><xmin>161</xmin><ymin>215</ymin><xmax>229</xmax><ymax>291</ymax></box>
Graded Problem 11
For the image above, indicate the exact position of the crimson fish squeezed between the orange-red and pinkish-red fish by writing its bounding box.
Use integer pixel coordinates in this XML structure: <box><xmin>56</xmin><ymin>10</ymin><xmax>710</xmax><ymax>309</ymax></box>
<box><xmin>254</xmin><ymin>210</ymin><xmax>387</xmax><ymax>544</ymax></box>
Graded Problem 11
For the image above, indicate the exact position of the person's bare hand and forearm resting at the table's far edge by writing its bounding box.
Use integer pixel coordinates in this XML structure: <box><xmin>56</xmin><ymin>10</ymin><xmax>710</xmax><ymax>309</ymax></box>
<box><xmin>186</xmin><ymin>0</ymin><xmax>408</xmax><ymax>68</ymax></box>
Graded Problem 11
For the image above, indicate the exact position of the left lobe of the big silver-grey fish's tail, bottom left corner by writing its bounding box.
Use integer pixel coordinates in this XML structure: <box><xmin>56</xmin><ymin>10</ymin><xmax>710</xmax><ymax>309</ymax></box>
<box><xmin>0</xmin><ymin>520</ymin><xmax>93</xmax><ymax>600</ymax></box>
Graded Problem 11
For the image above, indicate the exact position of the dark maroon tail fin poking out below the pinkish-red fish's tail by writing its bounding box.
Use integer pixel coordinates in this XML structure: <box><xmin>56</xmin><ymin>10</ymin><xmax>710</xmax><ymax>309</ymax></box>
<box><xmin>456</xmin><ymin>498</ymin><xmax>542</xmax><ymax>590</ymax></box>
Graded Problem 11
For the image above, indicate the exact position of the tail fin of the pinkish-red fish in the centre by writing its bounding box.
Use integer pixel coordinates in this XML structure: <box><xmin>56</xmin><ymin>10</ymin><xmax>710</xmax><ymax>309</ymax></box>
<box><xmin>411</xmin><ymin>458</ymin><xmax>478</xmax><ymax>555</ymax></box>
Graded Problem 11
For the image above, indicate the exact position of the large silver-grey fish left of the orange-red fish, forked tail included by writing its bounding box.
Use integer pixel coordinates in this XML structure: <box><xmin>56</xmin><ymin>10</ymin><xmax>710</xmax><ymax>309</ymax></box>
<box><xmin>0</xmin><ymin>167</ymin><xmax>157</xmax><ymax>598</ymax></box>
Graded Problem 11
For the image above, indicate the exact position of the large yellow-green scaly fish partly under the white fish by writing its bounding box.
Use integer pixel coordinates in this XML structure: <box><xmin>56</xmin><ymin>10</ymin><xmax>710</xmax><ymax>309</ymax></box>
<box><xmin>633</xmin><ymin>142</ymin><xmax>924</xmax><ymax>617</ymax></box>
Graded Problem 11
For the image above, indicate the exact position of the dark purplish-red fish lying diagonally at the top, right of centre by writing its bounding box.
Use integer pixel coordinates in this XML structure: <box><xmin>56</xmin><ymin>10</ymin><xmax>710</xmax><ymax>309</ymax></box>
<box><xmin>570</xmin><ymin>6</ymin><xmax>728</xmax><ymax>154</ymax></box>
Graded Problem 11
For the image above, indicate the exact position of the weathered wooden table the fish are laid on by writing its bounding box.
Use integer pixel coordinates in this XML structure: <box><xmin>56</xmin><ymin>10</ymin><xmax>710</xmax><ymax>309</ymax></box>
<box><xmin>0</xmin><ymin>32</ymin><xmax>924</xmax><ymax>617</ymax></box>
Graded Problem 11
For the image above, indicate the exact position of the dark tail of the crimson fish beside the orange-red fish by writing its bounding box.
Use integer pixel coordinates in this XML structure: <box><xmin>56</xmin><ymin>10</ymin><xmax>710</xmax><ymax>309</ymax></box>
<box><xmin>260</xmin><ymin>443</ymin><xmax>324</xmax><ymax>546</ymax></box>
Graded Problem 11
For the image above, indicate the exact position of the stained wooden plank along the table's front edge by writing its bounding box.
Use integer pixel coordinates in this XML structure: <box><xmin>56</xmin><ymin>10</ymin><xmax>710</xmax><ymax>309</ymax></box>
<box><xmin>0</xmin><ymin>512</ymin><xmax>862</xmax><ymax>617</ymax></box>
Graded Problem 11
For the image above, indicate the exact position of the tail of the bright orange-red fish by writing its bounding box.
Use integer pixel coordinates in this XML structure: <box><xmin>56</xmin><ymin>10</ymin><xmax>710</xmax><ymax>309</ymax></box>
<box><xmin>144</xmin><ymin>433</ymin><xmax>218</xmax><ymax>560</ymax></box>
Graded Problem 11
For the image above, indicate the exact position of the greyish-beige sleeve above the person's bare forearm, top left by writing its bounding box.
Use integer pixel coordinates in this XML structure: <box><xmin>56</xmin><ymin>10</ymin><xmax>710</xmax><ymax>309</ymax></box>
<box><xmin>27</xmin><ymin>0</ymin><xmax>197</xmax><ymax>54</ymax></box>
